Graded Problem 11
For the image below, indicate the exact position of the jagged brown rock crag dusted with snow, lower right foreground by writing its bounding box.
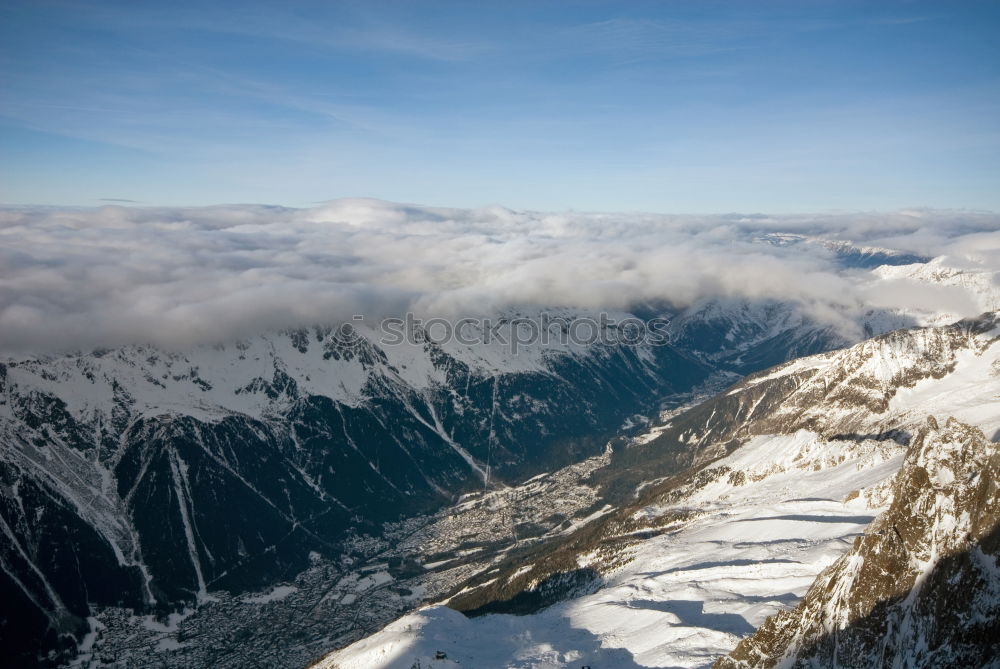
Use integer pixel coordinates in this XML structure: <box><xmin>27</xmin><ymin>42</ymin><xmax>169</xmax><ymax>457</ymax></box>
<box><xmin>714</xmin><ymin>418</ymin><xmax>1000</xmax><ymax>669</ymax></box>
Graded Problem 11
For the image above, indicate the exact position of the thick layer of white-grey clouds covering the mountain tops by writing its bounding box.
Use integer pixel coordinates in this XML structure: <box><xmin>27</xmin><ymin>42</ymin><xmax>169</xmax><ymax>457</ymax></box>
<box><xmin>0</xmin><ymin>199</ymin><xmax>1000</xmax><ymax>355</ymax></box>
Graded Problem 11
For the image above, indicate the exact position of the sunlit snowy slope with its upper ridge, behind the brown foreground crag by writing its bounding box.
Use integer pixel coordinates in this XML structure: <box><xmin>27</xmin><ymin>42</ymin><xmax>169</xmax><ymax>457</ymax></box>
<box><xmin>319</xmin><ymin>318</ymin><xmax>1000</xmax><ymax>669</ymax></box>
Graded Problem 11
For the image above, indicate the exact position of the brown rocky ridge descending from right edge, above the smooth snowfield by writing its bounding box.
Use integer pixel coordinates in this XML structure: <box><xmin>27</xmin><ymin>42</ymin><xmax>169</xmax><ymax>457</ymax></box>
<box><xmin>426</xmin><ymin>314</ymin><xmax>1000</xmax><ymax>611</ymax></box>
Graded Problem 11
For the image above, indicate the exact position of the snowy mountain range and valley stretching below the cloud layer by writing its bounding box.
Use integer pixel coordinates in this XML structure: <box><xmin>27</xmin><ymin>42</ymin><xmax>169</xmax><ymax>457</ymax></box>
<box><xmin>0</xmin><ymin>248</ymin><xmax>1000</xmax><ymax>669</ymax></box>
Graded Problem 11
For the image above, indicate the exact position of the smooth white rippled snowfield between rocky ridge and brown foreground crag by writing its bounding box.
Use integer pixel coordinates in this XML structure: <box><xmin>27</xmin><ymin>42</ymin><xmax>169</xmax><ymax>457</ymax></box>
<box><xmin>322</xmin><ymin>431</ymin><xmax>902</xmax><ymax>669</ymax></box>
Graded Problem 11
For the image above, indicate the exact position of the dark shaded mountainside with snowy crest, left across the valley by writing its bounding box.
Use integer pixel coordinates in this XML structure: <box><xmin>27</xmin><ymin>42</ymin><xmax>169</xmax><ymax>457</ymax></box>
<box><xmin>0</xmin><ymin>318</ymin><xmax>708</xmax><ymax>663</ymax></box>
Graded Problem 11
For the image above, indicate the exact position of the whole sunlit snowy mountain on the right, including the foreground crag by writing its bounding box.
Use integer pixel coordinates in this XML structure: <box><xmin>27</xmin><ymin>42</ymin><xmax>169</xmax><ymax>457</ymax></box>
<box><xmin>321</xmin><ymin>316</ymin><xmax>1000</xmax><ymax>669</ymax></box>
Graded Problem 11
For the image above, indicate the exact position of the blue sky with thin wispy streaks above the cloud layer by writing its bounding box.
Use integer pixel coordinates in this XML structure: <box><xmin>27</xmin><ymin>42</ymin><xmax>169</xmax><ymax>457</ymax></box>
<box><xmin>0</xmin><ymin>0</ymin><xmax>1000</xmax><ymax>213</ymax></box>
